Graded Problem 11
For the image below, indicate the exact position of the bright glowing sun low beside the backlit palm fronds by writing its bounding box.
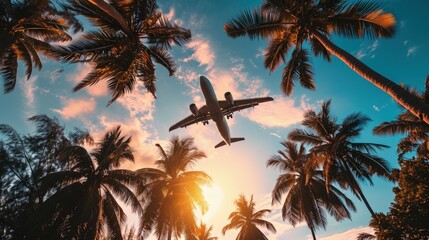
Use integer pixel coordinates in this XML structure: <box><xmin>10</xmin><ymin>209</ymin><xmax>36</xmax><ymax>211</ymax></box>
<box><xmin>197</xmin><ymin>184</ymin><xmax>223</xmax><ymax>222</ymax></box>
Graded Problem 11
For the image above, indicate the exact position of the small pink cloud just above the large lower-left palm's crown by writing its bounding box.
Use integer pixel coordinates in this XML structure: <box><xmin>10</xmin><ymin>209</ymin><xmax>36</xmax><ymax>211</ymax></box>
<box><xmin>53</xmin><ymin>98</ymin><xmax>96</xmax><ymax>120</ymax></box>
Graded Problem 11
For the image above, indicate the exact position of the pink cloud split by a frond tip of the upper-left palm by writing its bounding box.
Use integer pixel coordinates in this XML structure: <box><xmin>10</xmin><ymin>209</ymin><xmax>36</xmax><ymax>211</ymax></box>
<box><xmin>67</xmin><ymin>63</ymin><xmax>109</xmax><ymax>97</ymax></box>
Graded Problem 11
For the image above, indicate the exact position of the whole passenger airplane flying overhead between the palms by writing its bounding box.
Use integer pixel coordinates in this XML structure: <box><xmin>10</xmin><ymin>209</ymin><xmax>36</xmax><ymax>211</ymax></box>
<box><xmin>169</xmin><ymin>76</ymin><xmax>274</xmax><ymax>148</ymax></box>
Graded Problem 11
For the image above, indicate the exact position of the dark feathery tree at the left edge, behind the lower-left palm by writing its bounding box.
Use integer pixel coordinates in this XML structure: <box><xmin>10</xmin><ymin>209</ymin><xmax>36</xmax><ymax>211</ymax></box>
<box><xmin>0</xmin><ymin>115</ymin><xmax>92</xmax><ymax>240</ymax></box>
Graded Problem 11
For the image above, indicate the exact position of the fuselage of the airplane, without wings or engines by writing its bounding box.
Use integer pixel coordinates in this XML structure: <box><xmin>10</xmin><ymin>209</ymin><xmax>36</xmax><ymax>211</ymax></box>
<box><xmin>200</xmin><ymin>76</ymin><xmax>231</xmax><ymax>145</ymax></box>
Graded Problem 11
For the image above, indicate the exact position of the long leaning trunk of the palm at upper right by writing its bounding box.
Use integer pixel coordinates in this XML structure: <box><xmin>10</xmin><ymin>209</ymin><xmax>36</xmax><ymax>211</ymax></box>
<box><xmin>310</xmin><ymin>30</ymin><xmax>429</xmax><ymax>124</ymax></box>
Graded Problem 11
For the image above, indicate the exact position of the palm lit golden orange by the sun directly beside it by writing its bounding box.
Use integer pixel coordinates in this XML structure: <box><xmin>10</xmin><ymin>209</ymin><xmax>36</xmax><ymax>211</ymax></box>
<box><xmin>136</xmin><ymin>137</ymin><xmax>211</xmax><ymax>240</ymax></box>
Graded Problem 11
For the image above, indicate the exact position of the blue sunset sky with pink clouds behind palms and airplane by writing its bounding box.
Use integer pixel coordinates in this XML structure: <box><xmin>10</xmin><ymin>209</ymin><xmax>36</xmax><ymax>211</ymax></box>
<box><xmin>0</xmin><ymin>0</ymin><xmax>429</xmax><ymax>240</ymax></box>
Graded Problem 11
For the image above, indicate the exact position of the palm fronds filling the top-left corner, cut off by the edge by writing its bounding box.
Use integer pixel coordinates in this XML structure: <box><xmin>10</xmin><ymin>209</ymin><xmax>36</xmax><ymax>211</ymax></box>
<box><xmin>0</xmin><ymin>0</ymin><xmax>74</xmax><ymax>93</ymax></box>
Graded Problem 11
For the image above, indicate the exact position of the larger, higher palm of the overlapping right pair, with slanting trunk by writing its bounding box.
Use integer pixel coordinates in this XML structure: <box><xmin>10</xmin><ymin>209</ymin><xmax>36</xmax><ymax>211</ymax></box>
<box><xmin>288</xmin><ymin>100</ymin><xmax>390</xmax><ymax>215</ymax></box>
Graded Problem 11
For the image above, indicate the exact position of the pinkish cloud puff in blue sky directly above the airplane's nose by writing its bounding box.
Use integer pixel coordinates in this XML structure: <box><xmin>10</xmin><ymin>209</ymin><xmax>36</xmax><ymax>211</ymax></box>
<box><xmin>182</xmin><ymin>35</ymin><xmax>216</xmax><ymax>71</ymax></box>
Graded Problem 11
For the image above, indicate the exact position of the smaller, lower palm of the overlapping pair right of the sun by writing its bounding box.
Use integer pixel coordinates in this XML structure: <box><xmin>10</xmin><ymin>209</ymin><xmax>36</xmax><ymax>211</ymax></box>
<box><xmin>267</xmin><ymin>141</ymin><xmax>355</xmax><ymax>239</ymax></box>
